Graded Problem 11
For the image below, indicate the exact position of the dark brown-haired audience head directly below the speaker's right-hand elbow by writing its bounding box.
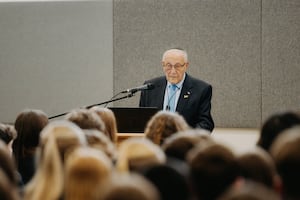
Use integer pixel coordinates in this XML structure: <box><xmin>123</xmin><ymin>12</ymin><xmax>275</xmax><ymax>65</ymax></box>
<box><xmin>187</xmin><ymin>143</ymin><xmax>238</xmax><ymax>200</ymax></box>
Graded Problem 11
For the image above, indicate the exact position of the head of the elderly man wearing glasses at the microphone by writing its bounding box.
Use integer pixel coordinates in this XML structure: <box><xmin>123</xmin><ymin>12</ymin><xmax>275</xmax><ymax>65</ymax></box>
<box><xmin>162</xmin><ymin>49</ymin><xmax>188</xmax><ymax>84</ymax></box>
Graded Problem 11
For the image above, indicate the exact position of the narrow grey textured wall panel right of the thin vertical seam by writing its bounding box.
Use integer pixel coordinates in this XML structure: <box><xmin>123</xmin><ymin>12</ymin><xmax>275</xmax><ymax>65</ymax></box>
<box><xmin>262</xmin><ymin>0</ymin><xmax>300</xmax><ymax>121</ymax></box>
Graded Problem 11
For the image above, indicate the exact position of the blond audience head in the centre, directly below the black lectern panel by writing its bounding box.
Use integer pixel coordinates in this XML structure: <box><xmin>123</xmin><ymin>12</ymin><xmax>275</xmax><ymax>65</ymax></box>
<box><xmin>116</xmin><ymin>138</ymin><xmax>166</xmax><ymax>172</ymax></box>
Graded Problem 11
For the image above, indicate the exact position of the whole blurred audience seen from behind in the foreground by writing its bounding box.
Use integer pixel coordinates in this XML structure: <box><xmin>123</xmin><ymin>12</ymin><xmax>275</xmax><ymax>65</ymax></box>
<box><xmin>0</xmin><ymin>107</ymin><xmax>300</xmax><ymax>200</ymax></box>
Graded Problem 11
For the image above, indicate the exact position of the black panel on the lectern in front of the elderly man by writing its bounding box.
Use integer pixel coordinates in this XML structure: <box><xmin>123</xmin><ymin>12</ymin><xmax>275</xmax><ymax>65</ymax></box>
<box><xmin>109</xmin><ymin>107</ymin><xmax>159</xmax><ymax>133</ymax></box>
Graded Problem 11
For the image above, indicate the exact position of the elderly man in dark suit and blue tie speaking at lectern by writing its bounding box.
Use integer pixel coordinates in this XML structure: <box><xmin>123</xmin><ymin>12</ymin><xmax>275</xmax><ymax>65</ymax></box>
<box><xmin>140</xmin><ymin>49</ymin><xmax>214</xmax><ymax>131</ymax></box>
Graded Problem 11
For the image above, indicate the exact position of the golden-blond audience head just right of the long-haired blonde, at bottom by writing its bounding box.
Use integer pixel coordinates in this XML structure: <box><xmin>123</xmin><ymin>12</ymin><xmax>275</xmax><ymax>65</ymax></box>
<box><xmin>64</xmin><ymin>147</ymin><xmax>112</xmax><ymax>200</ymax></box>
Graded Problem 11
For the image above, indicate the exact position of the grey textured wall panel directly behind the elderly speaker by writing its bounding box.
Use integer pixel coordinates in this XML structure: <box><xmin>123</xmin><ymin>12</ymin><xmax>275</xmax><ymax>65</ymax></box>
<box><xmin>114</xmin><ymin>0</ymin><xmax>261</xmax><ymax>127</ymax></box>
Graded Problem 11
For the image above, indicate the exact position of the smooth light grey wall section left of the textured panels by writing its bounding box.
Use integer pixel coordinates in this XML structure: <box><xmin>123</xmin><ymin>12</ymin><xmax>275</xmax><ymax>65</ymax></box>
<box><xmin>0</xmin><ymin>0</ymin><xmax>113</xmax><ymax>122</ymax></box>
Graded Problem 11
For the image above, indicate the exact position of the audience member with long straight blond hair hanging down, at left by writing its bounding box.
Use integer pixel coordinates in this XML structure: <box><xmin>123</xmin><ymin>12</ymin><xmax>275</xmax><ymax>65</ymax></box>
<box><xmin>24</xmin><ymin>121</ymin><xmax>87</xmax><ymax>200</ymax></box>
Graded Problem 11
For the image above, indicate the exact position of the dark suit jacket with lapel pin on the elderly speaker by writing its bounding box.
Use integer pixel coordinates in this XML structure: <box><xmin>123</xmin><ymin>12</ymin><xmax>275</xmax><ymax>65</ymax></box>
<box><xmin>140</xmin><ymin>74</ymin><xmax>214</xmax><ymax>131</ymax></box>
